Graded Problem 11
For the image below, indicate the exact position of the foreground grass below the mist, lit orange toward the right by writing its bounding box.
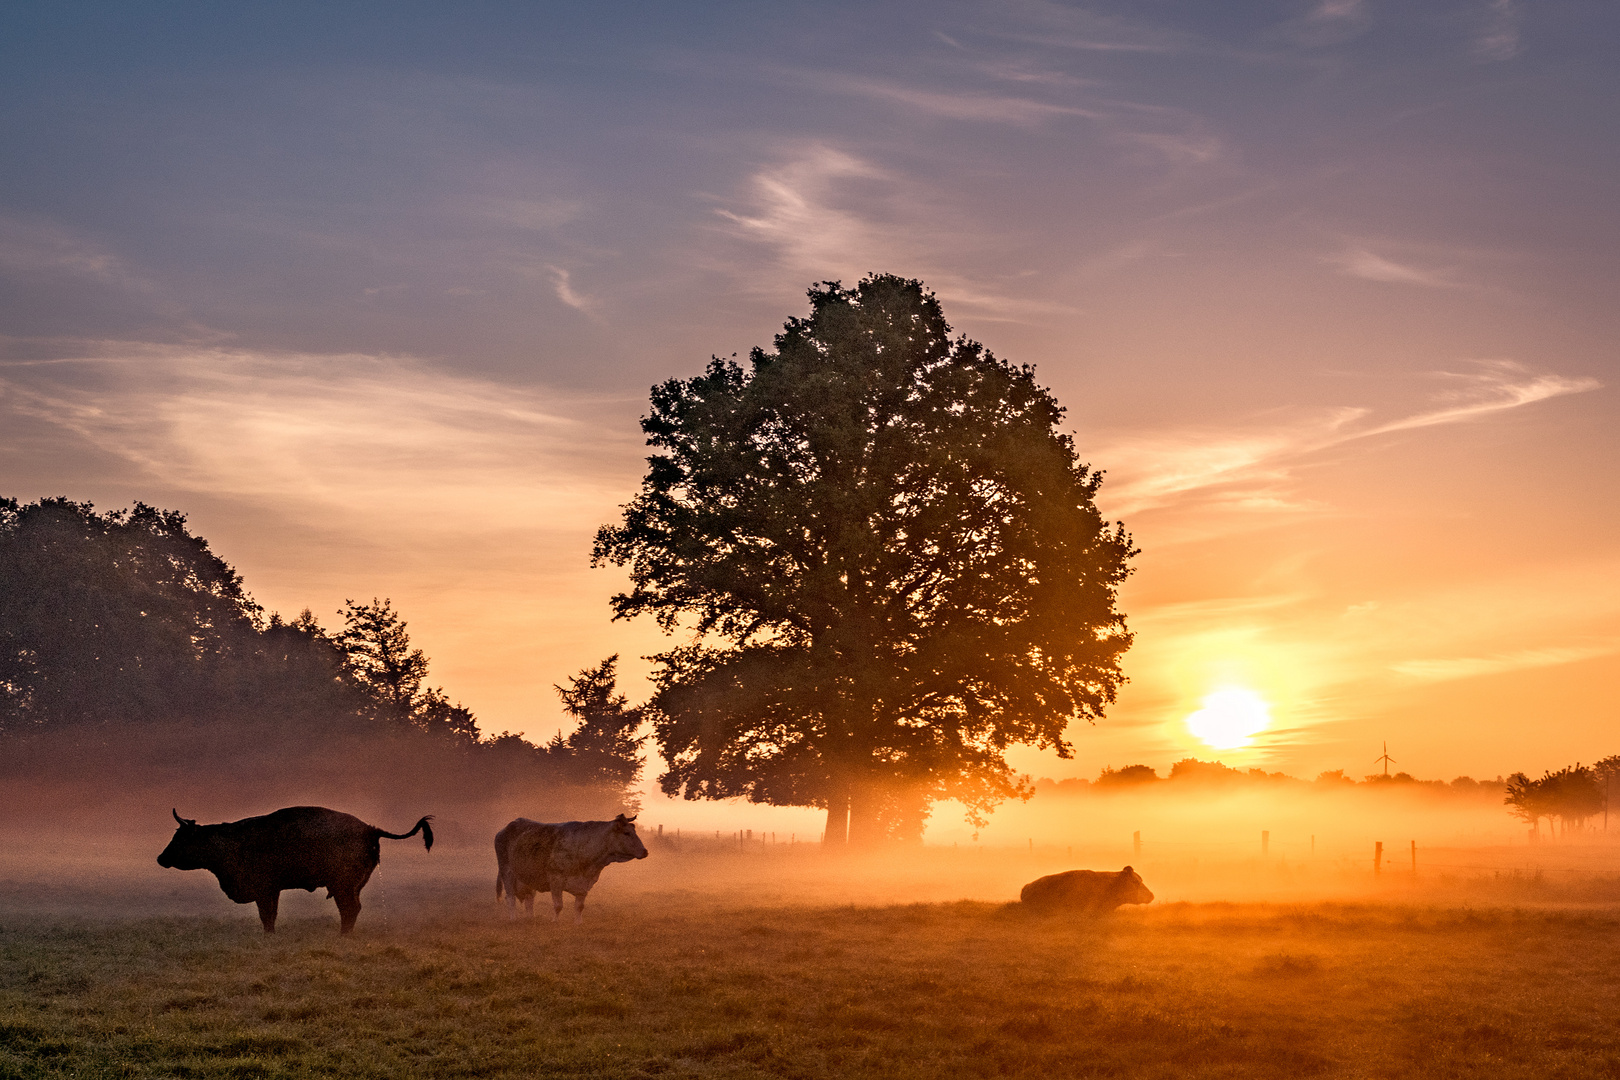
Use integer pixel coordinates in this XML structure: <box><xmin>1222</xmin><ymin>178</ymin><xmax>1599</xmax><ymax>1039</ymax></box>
<box><xmin>0</xmin><ymin>894</ymin><xmax>1620</xmax><ymax>1078</ymax></box>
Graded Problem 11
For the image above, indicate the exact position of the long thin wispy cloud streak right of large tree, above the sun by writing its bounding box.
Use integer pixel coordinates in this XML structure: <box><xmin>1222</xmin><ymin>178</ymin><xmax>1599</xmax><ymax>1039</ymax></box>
<box><xmin>1094</xmin><ymin>359</ymin><xmax>1602</xmax><ymax>517</ymax></box>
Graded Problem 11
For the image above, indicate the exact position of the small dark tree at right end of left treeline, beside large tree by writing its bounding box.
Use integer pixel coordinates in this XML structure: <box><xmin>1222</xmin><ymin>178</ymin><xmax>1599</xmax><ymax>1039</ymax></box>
<box><xmin>546</xmin><ymin>653</ymin><xmax>646</xmax><ymax>808</ymax></box>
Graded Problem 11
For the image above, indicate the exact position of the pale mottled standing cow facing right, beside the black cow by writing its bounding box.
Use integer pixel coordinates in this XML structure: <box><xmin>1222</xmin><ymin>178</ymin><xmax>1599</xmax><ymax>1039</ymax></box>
<box><xmin>496</xmin><ymin>814</ymin><xmax>646</xmax><ymax>923</ymax></box>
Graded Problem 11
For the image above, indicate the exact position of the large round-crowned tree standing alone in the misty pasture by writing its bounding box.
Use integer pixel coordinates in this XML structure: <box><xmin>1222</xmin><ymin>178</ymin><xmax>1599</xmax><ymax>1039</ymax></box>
<box><xmin>595</xmin><ymin>275</ymin><xmax>1134</xmax><ymax>844</ymax></box>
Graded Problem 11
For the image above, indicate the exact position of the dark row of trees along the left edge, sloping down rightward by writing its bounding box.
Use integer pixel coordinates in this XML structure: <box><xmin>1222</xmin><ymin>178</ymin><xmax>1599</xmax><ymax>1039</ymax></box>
<box><xmin>0</xmin><ymin>499</ymin><xmax>643</xmax><ymax>813</ymax></box>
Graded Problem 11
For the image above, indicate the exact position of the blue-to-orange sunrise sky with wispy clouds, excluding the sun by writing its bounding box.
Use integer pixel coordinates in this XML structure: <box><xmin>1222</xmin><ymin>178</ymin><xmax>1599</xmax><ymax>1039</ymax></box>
<box><xmin>0</xmin><ymin>0</ymin><xmax>1620</xmax><ymax>809</ymax></box>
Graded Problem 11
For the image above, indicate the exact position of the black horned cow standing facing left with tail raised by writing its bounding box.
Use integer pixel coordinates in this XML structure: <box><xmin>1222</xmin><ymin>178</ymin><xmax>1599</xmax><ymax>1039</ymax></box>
<box><xmin>157</xmin><ymin>806</ymin><xmax>433</xmax><ymax>934</ymax></box>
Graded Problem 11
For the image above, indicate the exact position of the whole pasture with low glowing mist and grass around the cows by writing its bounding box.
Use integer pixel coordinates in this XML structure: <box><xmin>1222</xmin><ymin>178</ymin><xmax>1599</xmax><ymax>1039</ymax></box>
<box><xmin>0</xmin><ymin>808</ymin><xmax>1620</xmax><ymax>1078</ymax></box>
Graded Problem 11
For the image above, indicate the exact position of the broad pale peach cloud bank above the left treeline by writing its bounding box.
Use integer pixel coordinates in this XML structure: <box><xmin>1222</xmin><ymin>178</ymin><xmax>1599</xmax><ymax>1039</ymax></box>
<box><xmin>0</xmin><ymin>343</ymin><xmax>642</xmax><ymax>533</ymax></box>
